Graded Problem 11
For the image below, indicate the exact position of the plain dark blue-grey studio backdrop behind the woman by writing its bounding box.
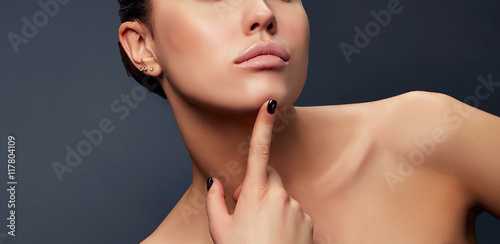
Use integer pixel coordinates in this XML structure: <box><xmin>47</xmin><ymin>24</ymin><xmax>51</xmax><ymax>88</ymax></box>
<box><xmin>0</xmin><ymin>0</ymin><xmax>500</xmax><ymax>243</ymax></box>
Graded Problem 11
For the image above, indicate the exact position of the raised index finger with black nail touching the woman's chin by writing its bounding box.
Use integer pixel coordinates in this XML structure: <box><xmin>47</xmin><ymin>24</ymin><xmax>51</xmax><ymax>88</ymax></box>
<box><xmin>245</xmin><ymin>100</ymin><xmax>278</xmax><ymax>185</ymax></box>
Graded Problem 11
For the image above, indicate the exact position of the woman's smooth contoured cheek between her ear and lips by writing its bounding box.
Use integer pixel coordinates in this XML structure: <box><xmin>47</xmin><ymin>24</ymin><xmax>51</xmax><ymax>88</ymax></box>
<box><xmin>155</xmin><ymin>8</ymin><xmax>235</xmax><ymax>103</ymax></box>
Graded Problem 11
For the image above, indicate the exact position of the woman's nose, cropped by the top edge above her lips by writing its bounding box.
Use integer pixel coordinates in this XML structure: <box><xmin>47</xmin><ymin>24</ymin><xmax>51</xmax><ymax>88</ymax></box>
<box><xmin>243</xmin><ymin>0</ymin><xmax>278</xmax><ymax>35</ymax></box>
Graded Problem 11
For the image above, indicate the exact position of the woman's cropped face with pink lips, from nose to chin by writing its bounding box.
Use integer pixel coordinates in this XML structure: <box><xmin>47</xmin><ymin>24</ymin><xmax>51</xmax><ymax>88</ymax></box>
<box><xmin>152</xmin><ymin>0</ymin><xmax>309</xmax><ymax>112</ymax></box>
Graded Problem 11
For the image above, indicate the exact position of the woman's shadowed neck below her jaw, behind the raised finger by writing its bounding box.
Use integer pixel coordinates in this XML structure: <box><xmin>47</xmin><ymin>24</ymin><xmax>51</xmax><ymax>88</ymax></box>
<box><xmin>167</xmin><ymin>85</ymin><xmax>299</xmax><ymax>213</ymax></box>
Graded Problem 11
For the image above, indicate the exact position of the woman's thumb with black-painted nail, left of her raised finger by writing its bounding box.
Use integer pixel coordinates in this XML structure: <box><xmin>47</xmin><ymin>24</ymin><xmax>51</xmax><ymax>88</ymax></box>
<box><xmin>206</xmin><ymin>177</ymin><xmax>231</xmax><ymax>238</ymax></box>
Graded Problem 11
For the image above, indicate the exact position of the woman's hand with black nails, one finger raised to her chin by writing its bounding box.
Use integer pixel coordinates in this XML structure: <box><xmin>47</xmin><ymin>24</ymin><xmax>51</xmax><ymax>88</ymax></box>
<box><xmin>206</xmin><ymin>100</ymin><xmax>313</xmax><ymax>244</ymax></box>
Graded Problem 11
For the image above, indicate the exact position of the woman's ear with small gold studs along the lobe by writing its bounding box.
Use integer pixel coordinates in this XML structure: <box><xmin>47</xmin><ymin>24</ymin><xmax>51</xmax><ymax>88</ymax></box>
<box><xmin>118</xmin><ymin>21</ymin><xmax>162</xmax><ymax>77</ymax></box>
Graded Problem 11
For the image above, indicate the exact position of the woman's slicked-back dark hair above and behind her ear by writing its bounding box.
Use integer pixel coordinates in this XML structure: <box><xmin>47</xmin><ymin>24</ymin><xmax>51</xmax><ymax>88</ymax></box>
<box><xmin>118</xmin><ymin>0</ymin><xmax>167</xmax><ymax>99</ymax></box>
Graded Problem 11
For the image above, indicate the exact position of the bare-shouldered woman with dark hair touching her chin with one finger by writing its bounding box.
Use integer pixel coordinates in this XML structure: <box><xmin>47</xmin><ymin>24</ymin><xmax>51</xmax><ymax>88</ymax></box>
<box><xmin>115</xmin><ymin>0</ymin><xmax>500</xmax><ymax>243</ymax></box>
